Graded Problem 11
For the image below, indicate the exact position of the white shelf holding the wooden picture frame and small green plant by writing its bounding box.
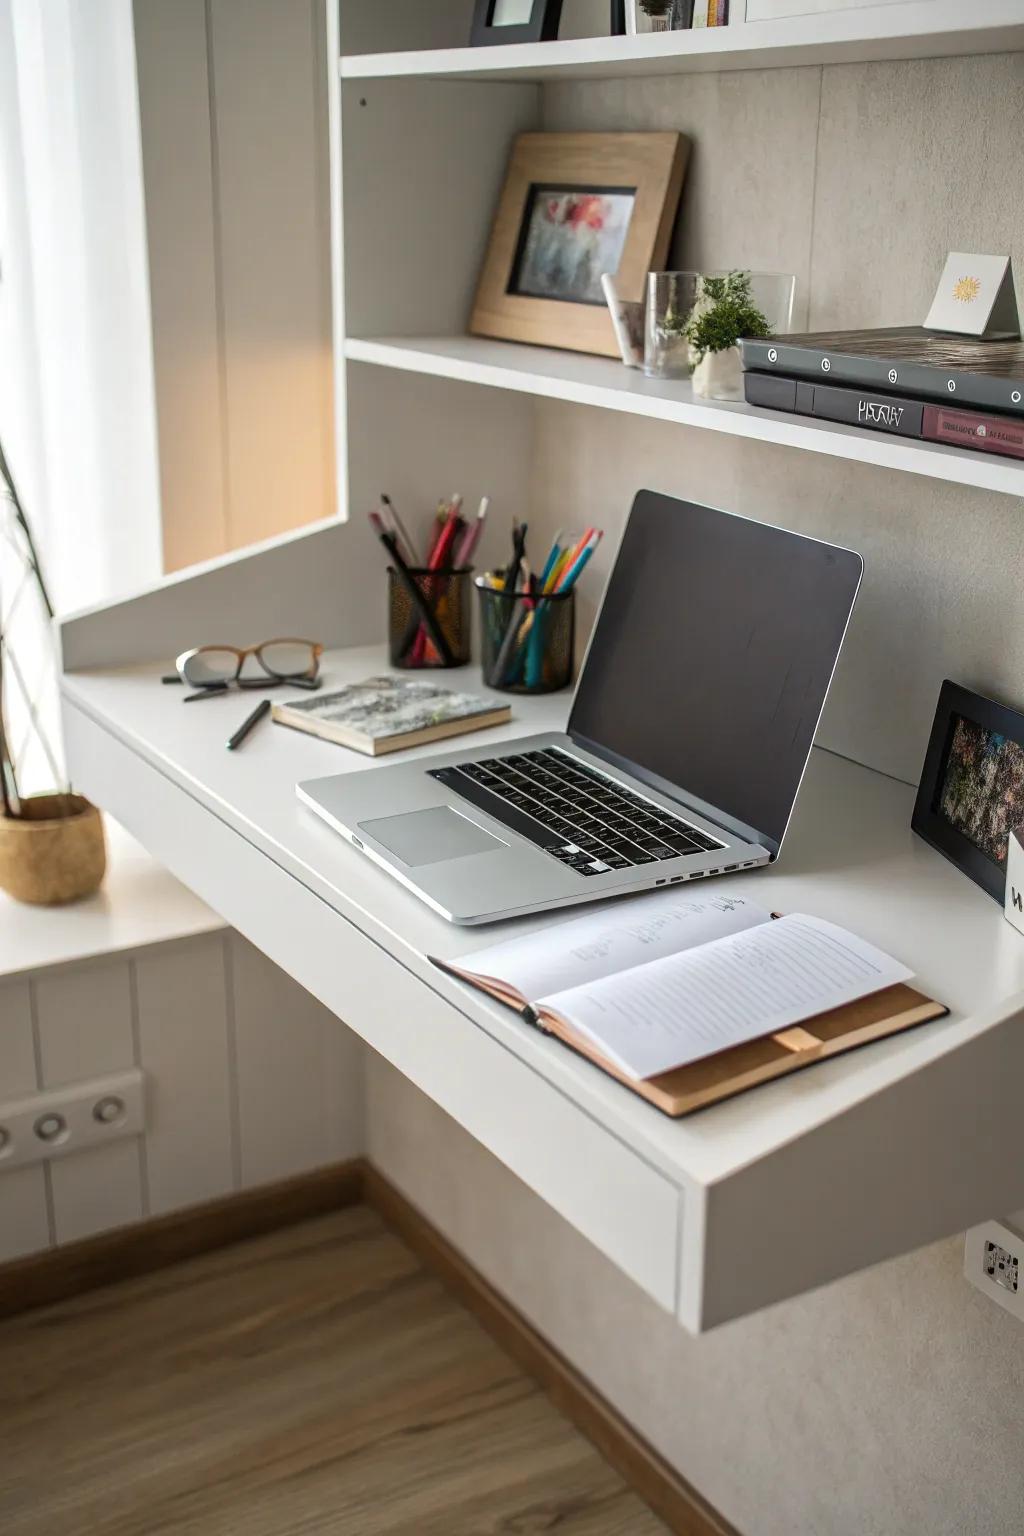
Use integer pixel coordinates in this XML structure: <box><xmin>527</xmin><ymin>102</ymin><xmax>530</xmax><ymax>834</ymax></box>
<box><xmin>345</xmin><ymin>336</ymin><xmax>1024</xmax><ymax>496</ymax></box>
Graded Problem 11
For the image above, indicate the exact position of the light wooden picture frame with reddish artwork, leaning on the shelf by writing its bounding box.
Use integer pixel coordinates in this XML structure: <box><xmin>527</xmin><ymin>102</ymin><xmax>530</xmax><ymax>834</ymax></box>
<box><xmin>470</xmin><ymin>134</ymin><xmax>689</xmax><ymax>358</ymax></box>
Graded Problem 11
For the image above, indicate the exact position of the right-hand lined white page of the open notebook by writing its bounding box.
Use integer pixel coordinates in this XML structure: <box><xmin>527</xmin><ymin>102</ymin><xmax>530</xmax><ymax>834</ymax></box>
<box><xmin>548</xmin><ymin>915</ymin><xmax>913</xmax><ymax>1078</ymax></box>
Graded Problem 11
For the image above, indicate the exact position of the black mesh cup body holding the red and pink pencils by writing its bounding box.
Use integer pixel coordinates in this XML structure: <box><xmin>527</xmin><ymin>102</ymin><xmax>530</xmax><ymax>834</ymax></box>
<box><xmin>387</xmin><ymin>565</ymin><xmax>473</xmax><ymax>668</ymax></box>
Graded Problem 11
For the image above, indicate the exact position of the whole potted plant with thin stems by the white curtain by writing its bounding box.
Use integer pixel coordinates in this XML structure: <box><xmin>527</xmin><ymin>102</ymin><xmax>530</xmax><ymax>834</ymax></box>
<box><xmin>0</xmin><ymin>445</ymin><xmax>106</xmax><ymax>906</ymax></box>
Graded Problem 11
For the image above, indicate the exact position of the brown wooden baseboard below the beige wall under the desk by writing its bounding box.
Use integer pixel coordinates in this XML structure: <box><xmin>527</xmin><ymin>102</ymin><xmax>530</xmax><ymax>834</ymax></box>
<box><xmin>364</xmin><ymin>1164</ymin><xmax>738</xmax><ymax>1536</ymax></box>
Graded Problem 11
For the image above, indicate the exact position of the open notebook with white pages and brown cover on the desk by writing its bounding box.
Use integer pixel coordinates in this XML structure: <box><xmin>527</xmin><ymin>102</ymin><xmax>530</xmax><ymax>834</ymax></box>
<box><xmin>434</xmin><ymin>891</ymin><xmax>946</xmax><ymax>1115</ymax></box>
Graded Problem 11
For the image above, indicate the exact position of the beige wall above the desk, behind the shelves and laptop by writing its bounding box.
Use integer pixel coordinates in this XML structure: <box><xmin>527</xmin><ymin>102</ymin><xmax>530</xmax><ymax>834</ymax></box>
<box><xmin>531</xmin><ymin>54</ymin><xmax>1024</xmax><ymax>782</ymax></box>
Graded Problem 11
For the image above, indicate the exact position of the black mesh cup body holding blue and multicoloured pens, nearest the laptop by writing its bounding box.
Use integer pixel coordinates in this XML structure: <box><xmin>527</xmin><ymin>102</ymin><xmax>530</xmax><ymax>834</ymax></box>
<box><xmin>476</xmin><ymin>576</ymin><xmax>576</xmax><ymax>693</ymax></box>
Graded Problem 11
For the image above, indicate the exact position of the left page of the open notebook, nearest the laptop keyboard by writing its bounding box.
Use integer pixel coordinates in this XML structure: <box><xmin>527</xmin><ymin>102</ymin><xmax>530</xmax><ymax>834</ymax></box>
<box><xmin>451</xmin><ymin>891</ymin><xmax>771</xmax><ymax>1003</ymax></box>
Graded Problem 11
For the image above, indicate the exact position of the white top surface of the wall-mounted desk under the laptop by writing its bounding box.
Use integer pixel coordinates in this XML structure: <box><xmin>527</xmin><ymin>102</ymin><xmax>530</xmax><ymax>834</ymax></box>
<box><xmin>63</xmin><ymin>647</ymin><xmax>1024</xmax><ymax>1186</ymax></box>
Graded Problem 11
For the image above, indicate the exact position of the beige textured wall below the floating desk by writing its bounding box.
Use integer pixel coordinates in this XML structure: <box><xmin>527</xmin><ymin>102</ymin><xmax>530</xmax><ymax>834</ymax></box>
<box><xmin>367</xmin><ymin>1057</ymin><xmax>1024</xmax><ymax>1536</ymax></box>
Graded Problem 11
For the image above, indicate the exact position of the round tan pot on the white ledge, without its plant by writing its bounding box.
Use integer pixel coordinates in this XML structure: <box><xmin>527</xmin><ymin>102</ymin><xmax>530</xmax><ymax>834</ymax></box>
<box><xmin>0</xmin><ymin>794</ymin><xmax>106</xmax><ymax>906</ymax></box>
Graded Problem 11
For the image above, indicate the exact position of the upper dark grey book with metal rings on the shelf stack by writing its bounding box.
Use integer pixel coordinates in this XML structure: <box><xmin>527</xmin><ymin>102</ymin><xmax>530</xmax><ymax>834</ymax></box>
<box><xmin>740</xmin><ymin>327</ymin><xmax>1024</xmax><ymax>416</ymax></box>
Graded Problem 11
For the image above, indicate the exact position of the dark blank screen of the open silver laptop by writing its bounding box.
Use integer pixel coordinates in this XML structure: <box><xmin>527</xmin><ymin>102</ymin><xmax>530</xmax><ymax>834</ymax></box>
<box><xmin>570</xmin><ymin>490</ymin><xmax>863</xmax><ymax>852</ymax></box>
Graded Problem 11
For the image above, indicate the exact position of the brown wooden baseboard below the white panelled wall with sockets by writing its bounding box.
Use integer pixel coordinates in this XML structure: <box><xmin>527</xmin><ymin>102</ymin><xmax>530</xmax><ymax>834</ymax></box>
<box><xmin>0</xmin><ymin>1158</ymin><xmax>365</xmax><ymax>1318</ymax></box>
